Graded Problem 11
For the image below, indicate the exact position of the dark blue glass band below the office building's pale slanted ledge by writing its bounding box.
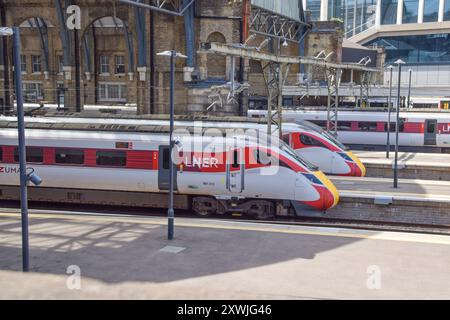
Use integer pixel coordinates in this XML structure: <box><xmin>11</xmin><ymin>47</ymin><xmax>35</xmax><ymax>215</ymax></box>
<box><xmin>367</xmin><ymin>34</ymin><xmax>450</xmax><ymax>64</ymax></box>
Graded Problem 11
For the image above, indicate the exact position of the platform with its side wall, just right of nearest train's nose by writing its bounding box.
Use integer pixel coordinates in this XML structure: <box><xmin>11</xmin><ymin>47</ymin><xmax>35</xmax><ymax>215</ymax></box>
<box><xmin>322</xmin><ymin>177</ymin><xmax>450</xmax><ymax>228</ymax></box>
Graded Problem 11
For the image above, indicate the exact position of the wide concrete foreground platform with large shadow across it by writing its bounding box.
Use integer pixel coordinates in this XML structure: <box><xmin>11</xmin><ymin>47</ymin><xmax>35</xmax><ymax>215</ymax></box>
<box><xmin>0</xmin><ymin>209</ymin><xmax>450</xmax><ymax>299</ymax></box>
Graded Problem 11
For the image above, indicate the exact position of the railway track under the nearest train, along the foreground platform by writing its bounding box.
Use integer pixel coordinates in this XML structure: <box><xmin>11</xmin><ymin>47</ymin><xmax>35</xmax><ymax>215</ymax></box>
<box><xmin>0</xmin><ymin>201</ymin><xmax>450</xmax><ymax>235</ymax></box>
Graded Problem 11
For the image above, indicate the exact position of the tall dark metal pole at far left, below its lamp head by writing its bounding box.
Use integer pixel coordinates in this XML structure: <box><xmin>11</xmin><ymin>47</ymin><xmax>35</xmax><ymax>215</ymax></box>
<box><xmin>13</xmin><ymin>27</ymin><xmax>29</xmax><ymax>272</ymax></box>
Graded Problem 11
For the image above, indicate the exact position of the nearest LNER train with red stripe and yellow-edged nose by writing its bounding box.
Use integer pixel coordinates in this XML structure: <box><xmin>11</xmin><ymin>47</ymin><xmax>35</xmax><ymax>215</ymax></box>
<box><xmin>0</xmin><ymin>121</ymin><xmax>339</xmax><ymax>218</ymax></box>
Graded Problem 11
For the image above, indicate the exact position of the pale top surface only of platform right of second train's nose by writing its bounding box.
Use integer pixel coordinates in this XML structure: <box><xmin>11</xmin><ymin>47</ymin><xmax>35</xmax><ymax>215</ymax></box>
<box><xmin>353</xmin><ymin>151</ymin><xmax>450</xmax><ymax>170</ymax></box>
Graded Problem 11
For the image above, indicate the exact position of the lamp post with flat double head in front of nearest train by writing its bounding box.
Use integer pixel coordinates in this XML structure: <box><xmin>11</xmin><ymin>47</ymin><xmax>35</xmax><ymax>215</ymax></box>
<box><xmin>157</xmin><ymin>50</ymin><xmax>187</xmax><ymax>240</ymax></box>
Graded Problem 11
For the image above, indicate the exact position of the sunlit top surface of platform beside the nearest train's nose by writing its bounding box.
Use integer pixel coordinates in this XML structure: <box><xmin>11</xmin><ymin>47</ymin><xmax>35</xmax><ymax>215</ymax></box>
<box><xmin>330</xmin><ymin>177</ymin><xmax>450</xmax><ymax>202</ymax></box>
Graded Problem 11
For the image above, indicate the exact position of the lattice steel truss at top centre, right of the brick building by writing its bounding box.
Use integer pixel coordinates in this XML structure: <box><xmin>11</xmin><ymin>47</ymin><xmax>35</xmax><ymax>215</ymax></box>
<box><xmin>249</xmin><ymin>6</ymin><xmax>308</xmax><ymax>43</ymax></box>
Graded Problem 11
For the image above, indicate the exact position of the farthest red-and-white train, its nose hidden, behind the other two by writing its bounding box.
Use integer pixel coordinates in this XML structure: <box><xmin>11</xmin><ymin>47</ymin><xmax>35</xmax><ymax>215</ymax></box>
<box><xmin>249</xmin><ymin>109</ymin><xmax>450</xmax><ymax>151</ymax></box>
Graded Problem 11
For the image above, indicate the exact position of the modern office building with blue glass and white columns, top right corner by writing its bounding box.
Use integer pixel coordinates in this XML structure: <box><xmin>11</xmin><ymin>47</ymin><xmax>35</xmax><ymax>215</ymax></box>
<box><xmin>306</xmin><ymin>0</ymin><xmax>450</xmax><ymax>65</ymax></box>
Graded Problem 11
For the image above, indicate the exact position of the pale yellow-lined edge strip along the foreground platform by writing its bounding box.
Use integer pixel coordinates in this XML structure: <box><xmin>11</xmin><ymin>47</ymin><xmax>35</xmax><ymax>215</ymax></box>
<box><xmin>0</xmin><ymin>212</ymin><xmax>450</xmax><ymax>245</ymax></box>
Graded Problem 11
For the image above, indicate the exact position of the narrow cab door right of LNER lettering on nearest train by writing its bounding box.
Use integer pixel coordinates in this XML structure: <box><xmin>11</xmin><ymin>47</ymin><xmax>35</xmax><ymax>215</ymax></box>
<box><xmin>226</xmin><ymin>149</ymin><xmax>245</xmax><ymax>194</ymax></box>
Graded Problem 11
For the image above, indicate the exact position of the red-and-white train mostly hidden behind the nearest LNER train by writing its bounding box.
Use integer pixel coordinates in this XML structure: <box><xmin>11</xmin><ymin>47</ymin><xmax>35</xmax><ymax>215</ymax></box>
<box><xmin>0</xmin><ymin>114</ymin><xmax>366</xmax><ymax>177</ymax></box>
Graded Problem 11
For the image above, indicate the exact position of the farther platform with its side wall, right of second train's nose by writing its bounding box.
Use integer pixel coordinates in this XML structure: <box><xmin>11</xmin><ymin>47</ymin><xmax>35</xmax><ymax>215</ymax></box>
<box><xmin>354</xmin><ymin>151</ymin><xmax>450</xmax><ymax>181</ymax></box>
